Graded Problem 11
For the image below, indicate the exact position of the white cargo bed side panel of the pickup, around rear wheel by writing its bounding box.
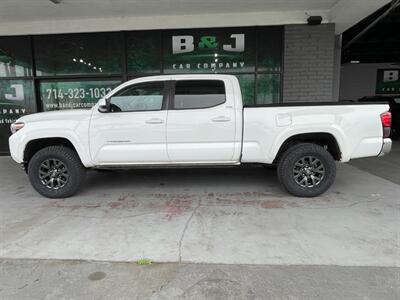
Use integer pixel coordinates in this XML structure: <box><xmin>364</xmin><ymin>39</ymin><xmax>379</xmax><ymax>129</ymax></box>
<box><xmin>242</xmin><ymin>105</ymin><xmax>388</xmax><ymax>164</ymax></box>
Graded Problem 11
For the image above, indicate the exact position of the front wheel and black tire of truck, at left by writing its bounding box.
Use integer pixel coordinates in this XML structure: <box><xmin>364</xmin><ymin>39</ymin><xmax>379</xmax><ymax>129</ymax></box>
<box><xmin>28</xmin><ymin>146</ymin><xmax>86</xmax><ymax>198</ymax></box>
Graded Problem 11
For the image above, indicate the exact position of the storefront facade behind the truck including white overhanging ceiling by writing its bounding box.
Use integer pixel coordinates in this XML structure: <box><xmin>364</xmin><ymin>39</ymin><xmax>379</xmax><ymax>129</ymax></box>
<box><xmin>0</xmin><ymin>0</ymin><xmax>388</xmax><ymax>154</ymax></box>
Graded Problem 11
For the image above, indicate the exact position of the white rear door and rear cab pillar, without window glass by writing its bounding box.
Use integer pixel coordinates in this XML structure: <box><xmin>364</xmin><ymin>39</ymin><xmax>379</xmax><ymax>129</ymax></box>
<box><xmin>167</xmin><ymin>75</ymin><xmax>242</xmax><ymax>164</ymax></box>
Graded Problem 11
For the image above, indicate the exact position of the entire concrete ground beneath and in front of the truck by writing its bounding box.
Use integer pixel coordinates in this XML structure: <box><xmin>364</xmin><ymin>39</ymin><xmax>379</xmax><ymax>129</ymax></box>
<box><xmin>0</xmin><ymin>151</ymin><xmax>400</xmax><ymax>300</ymax></box>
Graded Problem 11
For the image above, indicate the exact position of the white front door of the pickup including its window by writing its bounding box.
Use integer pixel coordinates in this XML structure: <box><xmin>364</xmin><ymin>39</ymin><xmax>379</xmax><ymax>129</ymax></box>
<box><xmin>89</xmin><ymin>81</ymin><xmax>169</xmax><ymax>164</ymax></box>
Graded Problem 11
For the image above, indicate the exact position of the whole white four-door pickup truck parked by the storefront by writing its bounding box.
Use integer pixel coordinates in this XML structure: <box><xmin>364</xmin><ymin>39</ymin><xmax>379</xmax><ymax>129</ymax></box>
<box><xmin>9</xmin><ymin>74</ymin><xmax>391</xmax><ymax>198</ymax></box>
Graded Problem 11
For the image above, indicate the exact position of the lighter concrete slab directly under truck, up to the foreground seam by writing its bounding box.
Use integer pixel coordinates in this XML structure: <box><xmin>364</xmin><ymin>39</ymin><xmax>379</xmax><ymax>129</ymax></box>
<box><xmin>0</xmin><ymin>157</ymin><xmax>400</xmax><ymax>267</ymax></box>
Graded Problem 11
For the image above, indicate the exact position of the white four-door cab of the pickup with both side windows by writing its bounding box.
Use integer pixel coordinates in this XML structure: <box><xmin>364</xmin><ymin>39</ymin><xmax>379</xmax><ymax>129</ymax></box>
<box><xmin>89</xmin><ymin>75</ymin><xmax>243</xmax><ymax>165</ymax></box>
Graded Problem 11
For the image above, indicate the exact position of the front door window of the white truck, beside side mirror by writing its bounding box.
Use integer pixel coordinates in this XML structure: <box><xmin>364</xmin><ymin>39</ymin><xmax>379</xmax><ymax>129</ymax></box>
<box><xmin>110</xmin><ymin>81</ymin><xmax>164</xmax><ymax>112</ymax></box>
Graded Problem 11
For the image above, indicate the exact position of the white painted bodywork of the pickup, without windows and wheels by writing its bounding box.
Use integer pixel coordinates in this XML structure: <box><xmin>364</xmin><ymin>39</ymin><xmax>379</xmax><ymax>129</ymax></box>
<box><xmin>9</xmin><ymin>74</ymin><xmax>389</xmax><ymax>167</ymax></box>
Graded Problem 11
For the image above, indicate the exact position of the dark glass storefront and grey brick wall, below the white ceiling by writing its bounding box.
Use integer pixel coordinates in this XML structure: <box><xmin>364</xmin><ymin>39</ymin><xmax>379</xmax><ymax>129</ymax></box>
<box><xmin>0</xmin><ymin>24</ymin><xmax>336</xmax><ymax>153</ymax></box>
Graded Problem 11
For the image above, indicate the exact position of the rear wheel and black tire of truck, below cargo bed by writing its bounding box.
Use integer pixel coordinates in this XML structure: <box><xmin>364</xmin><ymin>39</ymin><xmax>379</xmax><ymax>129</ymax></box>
<box><xmin>278</xmin><ymin>143</ymin><xmax>336</xmax><ymax>197</ymax></box>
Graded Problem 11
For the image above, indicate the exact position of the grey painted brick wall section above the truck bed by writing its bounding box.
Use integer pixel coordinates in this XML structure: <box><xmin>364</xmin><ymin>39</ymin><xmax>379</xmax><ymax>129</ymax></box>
<box><xmin>283</xmin><ymin>24</ymin><xmax>339</xmax><ymax>102</ymax></box>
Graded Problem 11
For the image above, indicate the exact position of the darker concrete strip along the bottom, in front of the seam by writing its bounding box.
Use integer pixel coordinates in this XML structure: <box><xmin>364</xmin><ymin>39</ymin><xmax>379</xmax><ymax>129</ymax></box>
<box><xmin>0</xmin><ymin>260</ymin><xmax>400</xmax><ymax>300</ymax></box>
